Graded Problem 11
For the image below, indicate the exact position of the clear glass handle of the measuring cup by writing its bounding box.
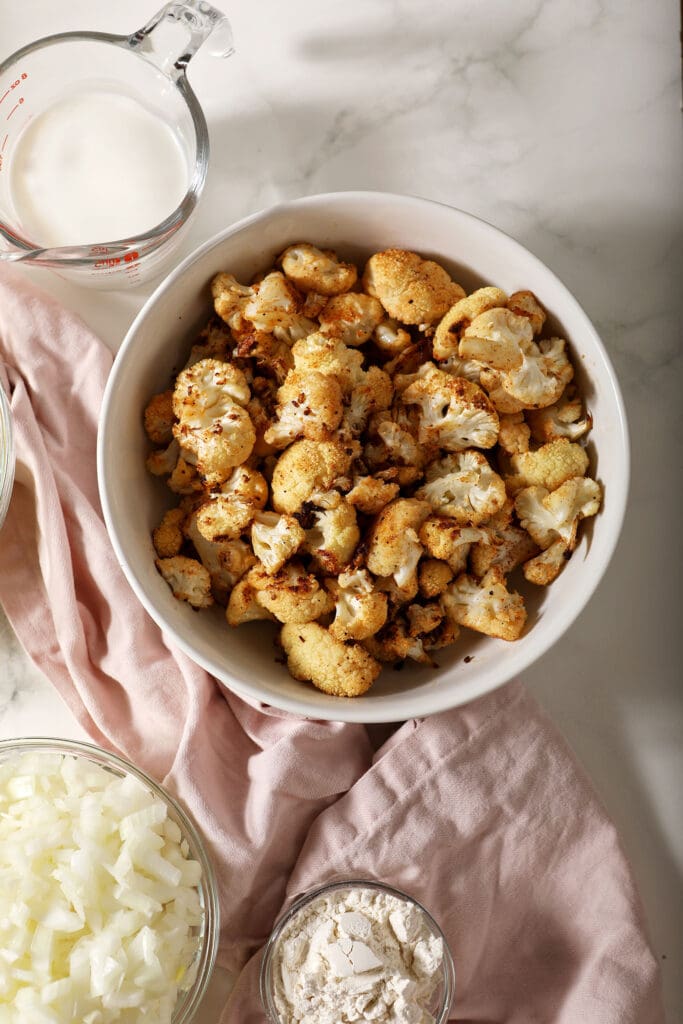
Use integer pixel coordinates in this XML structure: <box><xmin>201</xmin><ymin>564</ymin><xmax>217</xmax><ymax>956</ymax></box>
<box><xmin>128</xmin><ymin>0</ymin><xmax>234</xmax><ymax>78</ymax></box>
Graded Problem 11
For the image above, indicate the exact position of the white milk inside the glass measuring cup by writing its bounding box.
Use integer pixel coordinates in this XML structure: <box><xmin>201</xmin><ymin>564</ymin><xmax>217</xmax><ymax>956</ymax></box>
<box><xmin>10</xmin><ymin>90</ymin><xmax>188</xmax><ymax>248</ymax></box>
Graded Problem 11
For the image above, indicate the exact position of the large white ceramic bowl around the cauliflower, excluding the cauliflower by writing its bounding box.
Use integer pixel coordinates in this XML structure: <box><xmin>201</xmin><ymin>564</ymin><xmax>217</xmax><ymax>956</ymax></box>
<box><xmin>97</xmin><ymin>191</ymin><xmax>629</xmax><ymax>722</ymax></box>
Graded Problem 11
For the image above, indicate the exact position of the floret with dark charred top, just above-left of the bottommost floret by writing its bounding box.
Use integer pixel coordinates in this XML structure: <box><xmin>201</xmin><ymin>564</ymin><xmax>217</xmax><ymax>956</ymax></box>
<box><xmin>247</xmin><ymin>562</ymin><xmax>334</xmax><ymax>623</ymax></box>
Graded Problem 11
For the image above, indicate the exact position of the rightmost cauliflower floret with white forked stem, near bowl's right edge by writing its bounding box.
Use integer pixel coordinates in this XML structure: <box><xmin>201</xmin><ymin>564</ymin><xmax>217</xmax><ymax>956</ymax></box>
<box><xmin>515</xmin><ymin>476</ymin><xmax>602</xmax><ymax>551</ymax></box>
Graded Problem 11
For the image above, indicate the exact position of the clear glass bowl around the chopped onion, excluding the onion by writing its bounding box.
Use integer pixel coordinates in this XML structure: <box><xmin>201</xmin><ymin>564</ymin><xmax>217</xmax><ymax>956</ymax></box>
<box><xmin>0</xmin><ymin>737</ymin><xmax>220</xmax><ymax>1024</ymax></box>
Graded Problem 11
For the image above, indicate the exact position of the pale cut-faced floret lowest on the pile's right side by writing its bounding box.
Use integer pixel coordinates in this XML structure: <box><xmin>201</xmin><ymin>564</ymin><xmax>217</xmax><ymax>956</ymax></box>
<box><xmin>441</xmin><ymin>568</ymin><xmax>526</xmax><ymax>640</ymax></box>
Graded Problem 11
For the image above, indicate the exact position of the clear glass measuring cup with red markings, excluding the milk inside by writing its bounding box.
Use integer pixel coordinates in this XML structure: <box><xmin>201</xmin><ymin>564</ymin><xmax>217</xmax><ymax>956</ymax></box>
<box><xmin>0</xmin><ymin>0</ymin><xmax>233</xmax><ymax>289</ymax></box>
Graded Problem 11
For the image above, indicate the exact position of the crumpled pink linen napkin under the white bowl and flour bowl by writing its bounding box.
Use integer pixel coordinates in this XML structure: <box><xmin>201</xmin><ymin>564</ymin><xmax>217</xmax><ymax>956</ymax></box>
<box><xmin>0</xmin><ymin>269</ymin><xmax>664</xmax><ymax>1024</ymax></box>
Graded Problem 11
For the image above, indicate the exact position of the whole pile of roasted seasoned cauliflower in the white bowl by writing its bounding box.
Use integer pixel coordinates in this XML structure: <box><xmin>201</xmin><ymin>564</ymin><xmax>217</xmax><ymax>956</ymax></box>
<box><xmin>142</xmin><ymin>242</ymin><xmax>602</xmax><ymax>697</ymax></box>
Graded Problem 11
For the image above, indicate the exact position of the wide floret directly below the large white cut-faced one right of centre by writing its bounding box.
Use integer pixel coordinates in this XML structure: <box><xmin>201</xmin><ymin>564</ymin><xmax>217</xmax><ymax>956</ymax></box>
<box><xmin>416</xmin><ymin>450</ymin><xmax>506</xmax><ymax>526</ymax></box>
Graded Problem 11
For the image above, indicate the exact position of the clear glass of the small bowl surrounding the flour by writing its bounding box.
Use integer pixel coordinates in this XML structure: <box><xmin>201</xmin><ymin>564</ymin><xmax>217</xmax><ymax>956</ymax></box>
<box><xmin>259</xmin><ymin>879</ymin><xmax>455</xmax><ymax>1024</ymax></box>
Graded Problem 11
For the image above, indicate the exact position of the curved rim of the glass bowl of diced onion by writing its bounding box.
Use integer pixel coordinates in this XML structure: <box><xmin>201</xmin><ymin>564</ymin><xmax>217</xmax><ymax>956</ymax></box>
<box><xmin>0</xmin><ymin>736</ymin><xmax>220</xmax><ymax>1024</ymax></box>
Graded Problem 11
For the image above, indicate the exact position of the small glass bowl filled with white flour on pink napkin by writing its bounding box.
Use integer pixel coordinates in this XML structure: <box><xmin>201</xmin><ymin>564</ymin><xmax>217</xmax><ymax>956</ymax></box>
<box><xmin>260</xmin><ymin>880</ymin><xmax>455</xmax><ymax>1024</ymax></box>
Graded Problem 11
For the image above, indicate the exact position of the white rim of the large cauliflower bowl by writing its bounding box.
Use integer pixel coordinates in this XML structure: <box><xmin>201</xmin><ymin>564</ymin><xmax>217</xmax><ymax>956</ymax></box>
<box><xmin>97</xmin><ymin>189</ymin><xmax>631</xmax><ymax>723</ymax></box>
